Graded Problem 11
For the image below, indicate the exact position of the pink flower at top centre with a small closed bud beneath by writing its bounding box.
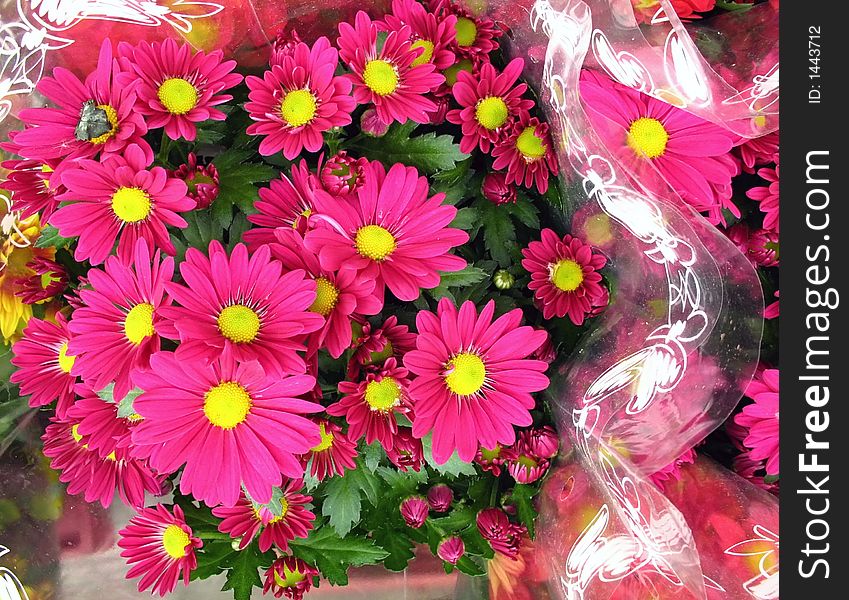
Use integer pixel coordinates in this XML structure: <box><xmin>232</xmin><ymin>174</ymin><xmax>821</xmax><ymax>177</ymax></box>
<box><xmin>337</xmin><ymin>11</ymin><xmax>445</xmax><ymax>123</ymax></box>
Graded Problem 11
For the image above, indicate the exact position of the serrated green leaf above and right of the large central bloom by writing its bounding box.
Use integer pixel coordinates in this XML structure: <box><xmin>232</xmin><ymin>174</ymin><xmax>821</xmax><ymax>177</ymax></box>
<box><xmin>351</xmin><ymin>123</ymin><xmax>469</xmax><ymax>174</ymax></box>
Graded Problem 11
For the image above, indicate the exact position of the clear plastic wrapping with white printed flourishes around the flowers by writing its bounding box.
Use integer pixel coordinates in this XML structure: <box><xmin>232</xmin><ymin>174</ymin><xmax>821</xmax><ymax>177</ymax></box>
<box><xmin>0</xmin><ymin>0</ymin><xmax>778</xmax><ymax>600</ymax></box>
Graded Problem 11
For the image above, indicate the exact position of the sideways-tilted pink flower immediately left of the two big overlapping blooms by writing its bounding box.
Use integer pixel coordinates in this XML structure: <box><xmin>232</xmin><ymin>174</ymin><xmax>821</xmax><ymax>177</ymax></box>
<box><xmin>69</xmin><ymin>240</ymin><xmax>174</xmax><ymax>402</ymax></box>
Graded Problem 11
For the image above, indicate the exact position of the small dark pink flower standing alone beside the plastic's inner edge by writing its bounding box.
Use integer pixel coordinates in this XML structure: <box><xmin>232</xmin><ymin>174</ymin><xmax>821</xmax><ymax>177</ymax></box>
<box><xmin>522</xmin><ymin>229</ymin><xmax>607</xmax><ymax>325</ymax></box>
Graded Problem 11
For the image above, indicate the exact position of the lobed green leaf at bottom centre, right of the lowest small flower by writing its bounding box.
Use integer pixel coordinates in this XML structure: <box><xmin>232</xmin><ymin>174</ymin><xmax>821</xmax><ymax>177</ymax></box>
<box><xmin>289</xmin><ymin>528</ymin><xmax>389</xmax><ymax>585</ymax></box>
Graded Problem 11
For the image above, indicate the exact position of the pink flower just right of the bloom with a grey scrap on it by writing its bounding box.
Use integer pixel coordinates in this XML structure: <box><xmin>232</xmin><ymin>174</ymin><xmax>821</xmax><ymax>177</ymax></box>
<box><xmin>118</xmin><ymin>39</ymin><xmax>242</xmax><ymax>142</ymax></box>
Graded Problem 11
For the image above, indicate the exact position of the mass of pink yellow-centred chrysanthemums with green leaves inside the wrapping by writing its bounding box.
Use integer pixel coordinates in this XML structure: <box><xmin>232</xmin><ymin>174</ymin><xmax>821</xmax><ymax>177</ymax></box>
<box><xmin>0</xmin><ymin>0</ymin><xmax>779</xmax><ymax>600</ymax></box>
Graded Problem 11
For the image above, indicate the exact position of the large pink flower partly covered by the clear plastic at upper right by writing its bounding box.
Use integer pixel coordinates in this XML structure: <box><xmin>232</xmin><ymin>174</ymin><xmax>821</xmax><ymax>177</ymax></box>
<box><xmin>581</xmin><ymin>70</ymin><xmax>740</xmax><ymax>224</ymax></box>
